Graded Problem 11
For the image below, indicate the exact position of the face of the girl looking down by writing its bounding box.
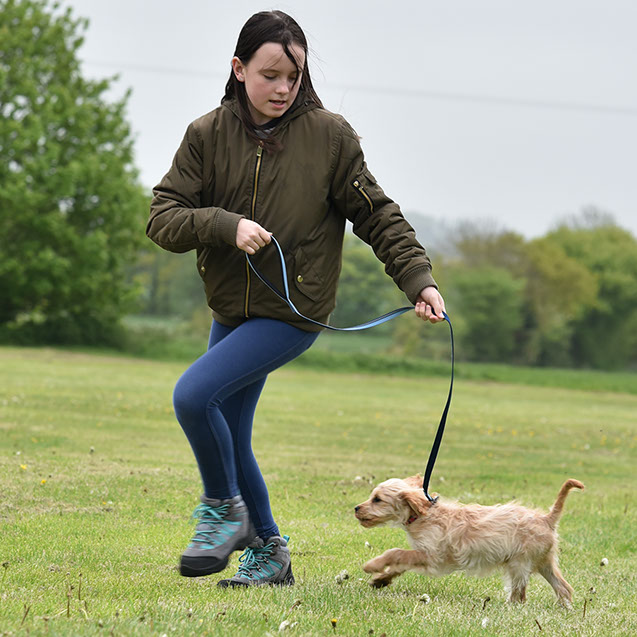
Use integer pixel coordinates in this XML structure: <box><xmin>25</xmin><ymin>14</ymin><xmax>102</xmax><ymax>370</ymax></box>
<box><xmin>232</xmin><ymin>42</ymin><xmax>305</xmax><ymax>126</ymax></box>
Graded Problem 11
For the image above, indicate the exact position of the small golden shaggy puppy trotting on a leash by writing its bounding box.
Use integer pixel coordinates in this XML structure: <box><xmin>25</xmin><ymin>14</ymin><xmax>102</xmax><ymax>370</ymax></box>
<box><xmin>354</xmin><ymin>476</ymin><xmax>584</xmax><ymax>607</ymax></box>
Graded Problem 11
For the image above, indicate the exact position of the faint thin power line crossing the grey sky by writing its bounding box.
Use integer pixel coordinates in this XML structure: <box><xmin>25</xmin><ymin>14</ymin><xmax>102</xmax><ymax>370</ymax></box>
<box><xmin>84</xmin><ymin>60</ymin><xmax>637</xmax><ymax>117</ymax></box>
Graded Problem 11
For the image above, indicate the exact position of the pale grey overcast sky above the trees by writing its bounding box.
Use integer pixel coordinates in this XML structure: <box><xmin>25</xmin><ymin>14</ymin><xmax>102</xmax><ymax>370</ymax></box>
<box><xmin>62</xmin><ymin>0</ymin><xmax>637</xmax><ymax>238</ymax></box>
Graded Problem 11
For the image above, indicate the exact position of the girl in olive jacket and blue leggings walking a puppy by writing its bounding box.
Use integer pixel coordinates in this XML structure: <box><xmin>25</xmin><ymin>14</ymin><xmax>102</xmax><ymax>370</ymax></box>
<box><xmin>147</xmin><ymin>11</ymin><xmax>444</xmax><ymax>586</ymax></box>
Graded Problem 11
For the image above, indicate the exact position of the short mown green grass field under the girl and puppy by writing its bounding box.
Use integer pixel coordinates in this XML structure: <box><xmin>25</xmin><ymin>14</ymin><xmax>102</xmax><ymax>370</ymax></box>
<box><xmin>0</xmin><ymin>348</ymin><xmax>637</xmax><ymax>637</ymax></box>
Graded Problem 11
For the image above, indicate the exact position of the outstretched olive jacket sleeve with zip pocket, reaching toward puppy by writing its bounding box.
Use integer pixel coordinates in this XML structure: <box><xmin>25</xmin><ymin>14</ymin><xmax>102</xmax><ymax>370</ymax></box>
<box><xmin>331</xmin><ymin>118</ymin><xmax>438</xmax><ymax>303</ymax></box>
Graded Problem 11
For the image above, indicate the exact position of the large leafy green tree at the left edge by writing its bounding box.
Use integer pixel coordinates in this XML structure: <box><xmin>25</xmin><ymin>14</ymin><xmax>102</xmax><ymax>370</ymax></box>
<box><xmin>0</xmin><ymin>0</ymin><xmax>147</xmax><ymax>343</ymax></box>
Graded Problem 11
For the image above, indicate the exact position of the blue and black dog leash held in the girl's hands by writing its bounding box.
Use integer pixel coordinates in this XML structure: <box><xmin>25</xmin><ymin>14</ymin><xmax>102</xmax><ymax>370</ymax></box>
<box><xmin>246</xmin><ymin>235</ymin><xmax>455</xmax><ymax>504</ymax></box>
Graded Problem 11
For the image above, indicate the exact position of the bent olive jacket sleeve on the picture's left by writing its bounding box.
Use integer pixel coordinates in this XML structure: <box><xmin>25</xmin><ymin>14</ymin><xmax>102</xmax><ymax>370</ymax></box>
<box><xmin>146</xmin><ymin>124</ymin><xmax>243</xmax><ymax>252</ymax></box>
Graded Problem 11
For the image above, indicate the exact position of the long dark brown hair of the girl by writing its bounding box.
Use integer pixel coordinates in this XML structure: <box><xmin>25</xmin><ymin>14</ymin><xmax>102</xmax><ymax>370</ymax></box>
<box><xmin>223</xmin><ymin>11</ymin><xmax>323</xmax><ymax>150</ymax></box>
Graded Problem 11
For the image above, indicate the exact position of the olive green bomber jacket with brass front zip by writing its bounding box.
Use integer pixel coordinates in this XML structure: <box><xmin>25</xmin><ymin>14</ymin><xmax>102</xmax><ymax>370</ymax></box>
<box><xmin>146</xmin><ymin>95</ymin><xmax>436</xmax><ymax>331</ymax></box>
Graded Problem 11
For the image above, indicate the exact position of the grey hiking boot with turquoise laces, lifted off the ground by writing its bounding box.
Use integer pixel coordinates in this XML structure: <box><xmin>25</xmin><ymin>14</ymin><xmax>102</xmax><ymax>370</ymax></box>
<box><xmin>179</xmin><ymin>495</ymin><xmax>255</xmax><ymax>577</ymax></box>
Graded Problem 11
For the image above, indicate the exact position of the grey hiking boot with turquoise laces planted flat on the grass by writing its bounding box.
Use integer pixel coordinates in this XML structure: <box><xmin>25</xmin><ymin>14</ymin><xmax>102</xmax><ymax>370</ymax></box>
<box><xmin>217</xmin><ymin>535</ymin><xmax>294</xmax><ymax>588</ymax></box>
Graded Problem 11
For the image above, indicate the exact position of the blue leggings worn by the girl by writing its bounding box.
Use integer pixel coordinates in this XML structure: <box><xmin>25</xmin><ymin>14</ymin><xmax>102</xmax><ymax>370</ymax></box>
<box><xmin>173</xmin><ymin>318</ymin><xmax>318</xmax><ymax>539</ymax></box>
